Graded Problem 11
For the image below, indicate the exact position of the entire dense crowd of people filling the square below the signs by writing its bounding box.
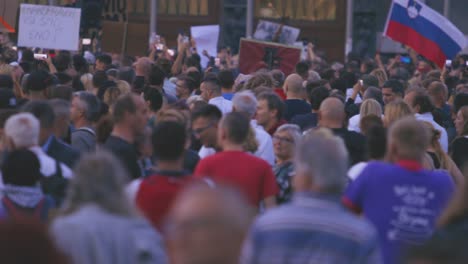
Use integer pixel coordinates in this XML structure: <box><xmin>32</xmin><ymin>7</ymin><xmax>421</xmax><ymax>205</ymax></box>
<box><xmin>0</xmin><ymin>31</ymin><xmax>468</xmax><ymax>264</ymax></box>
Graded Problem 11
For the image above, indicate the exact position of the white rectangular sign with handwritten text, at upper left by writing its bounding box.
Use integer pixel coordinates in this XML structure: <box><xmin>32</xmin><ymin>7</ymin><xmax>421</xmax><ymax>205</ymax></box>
<box><xmin>18</xmin><ymin>4</ymin><xmax>81</xmax><ymax>50</ymax></box>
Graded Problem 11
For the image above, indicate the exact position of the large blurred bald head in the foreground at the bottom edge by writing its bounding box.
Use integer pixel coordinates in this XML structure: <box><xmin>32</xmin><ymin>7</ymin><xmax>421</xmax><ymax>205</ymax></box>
<box><xmin>166</xmin><ymin>186</ymin><xmax>253</xmax><ymax>264</ymax></box>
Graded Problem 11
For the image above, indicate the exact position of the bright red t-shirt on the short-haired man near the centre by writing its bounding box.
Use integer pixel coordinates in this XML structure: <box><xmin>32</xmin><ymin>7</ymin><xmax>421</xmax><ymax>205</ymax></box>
<box><xmin>194</xmin><ymin>151</ymin><xmax>279</xmax><ymax>207</ymax></box>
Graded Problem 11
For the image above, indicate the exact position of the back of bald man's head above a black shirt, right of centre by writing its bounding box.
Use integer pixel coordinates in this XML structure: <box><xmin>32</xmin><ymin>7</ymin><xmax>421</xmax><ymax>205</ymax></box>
<box><xmin>319</xmin><ymin>97</ymin><xmax>346</xmax><ymax>128</ymax></box>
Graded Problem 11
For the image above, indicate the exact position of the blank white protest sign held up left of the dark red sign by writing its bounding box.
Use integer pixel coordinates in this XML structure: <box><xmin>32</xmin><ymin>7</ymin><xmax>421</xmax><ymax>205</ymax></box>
<box><xmin>190</xmin><ymin>25</ymin><xmax>219</xmax><ymax>68</ymax></box>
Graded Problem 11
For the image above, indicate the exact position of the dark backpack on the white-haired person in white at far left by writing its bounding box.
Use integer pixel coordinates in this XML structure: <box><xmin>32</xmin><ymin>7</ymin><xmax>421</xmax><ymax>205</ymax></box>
<box><xmin>40</xmin><ymin>160</ymin><xmax>68</xmax><ymax>206</ymax></box>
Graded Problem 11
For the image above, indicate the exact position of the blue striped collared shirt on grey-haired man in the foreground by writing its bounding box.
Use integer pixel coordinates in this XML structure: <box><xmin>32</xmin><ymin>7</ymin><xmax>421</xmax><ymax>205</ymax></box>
<box><xmin>241</xmin><ymin>193</ymin><xmax>381</xmax><ymax>264</ymax></box>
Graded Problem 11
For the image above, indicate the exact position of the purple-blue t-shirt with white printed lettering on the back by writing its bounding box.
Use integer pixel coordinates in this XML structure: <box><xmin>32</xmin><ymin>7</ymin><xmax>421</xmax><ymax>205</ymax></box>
<box><xmin>343</xmin><ymin>162</ymin><xmax>454</xmax><ymax>264</ymax></box>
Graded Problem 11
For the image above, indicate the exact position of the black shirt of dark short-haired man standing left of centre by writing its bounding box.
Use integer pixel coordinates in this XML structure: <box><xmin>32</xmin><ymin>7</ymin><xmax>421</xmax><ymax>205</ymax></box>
<box><xmin>103</xmin><ymin>135</ymin><xmax>142</xmax><ymax>179</ymax></box>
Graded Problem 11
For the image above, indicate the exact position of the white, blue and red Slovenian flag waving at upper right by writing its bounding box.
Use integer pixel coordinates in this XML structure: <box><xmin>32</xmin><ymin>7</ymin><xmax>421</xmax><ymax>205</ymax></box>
<box><xmin>384</xmin><ymin>0</ymin><xmax>467</xmax><ymax>68</ymax></box>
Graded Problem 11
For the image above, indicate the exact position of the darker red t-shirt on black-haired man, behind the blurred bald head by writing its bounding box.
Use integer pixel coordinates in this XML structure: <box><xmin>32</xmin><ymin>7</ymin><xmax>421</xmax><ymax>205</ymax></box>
<box><xmin>136</xmin><ymin>174</ymin><xmax>195</xmax><ymax>230</ymax></box>
